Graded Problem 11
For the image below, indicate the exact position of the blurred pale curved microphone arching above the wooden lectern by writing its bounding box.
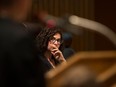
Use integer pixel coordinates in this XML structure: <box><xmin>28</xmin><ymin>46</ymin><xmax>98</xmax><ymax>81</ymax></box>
<box><xmin>67</xmin><ymin>15</ymin><xmax>116</xmax><ymax>46</ymax></box>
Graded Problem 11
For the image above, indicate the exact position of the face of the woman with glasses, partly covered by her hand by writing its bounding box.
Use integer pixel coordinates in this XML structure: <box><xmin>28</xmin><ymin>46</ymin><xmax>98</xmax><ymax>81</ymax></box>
<box><xmin>48</xmin><ymin>33</ymin><xmax>62</xmax><ymax>50</ymax></box>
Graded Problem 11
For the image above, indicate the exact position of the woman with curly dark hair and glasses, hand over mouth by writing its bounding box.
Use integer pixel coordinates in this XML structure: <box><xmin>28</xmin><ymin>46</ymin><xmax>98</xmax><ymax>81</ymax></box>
<box><xmin>36</xmin><ymin>27</ymin><xmax>66</xmax><ymax>71</ymax></box>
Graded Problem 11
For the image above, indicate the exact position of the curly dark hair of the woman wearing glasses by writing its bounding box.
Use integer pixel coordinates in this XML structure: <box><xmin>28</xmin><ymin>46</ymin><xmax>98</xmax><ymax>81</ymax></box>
<box><xmin>36</xmin><ymin>27</ymin><xmax>63</xmax><ymax>54</ymax></box>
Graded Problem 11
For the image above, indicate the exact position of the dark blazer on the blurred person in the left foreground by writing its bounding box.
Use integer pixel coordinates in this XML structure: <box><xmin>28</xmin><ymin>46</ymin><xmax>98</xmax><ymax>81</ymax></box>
<box><xmin>0</xmin><ymin>18</ymin><xmax>44</xmax><ymax>87</ymax></box>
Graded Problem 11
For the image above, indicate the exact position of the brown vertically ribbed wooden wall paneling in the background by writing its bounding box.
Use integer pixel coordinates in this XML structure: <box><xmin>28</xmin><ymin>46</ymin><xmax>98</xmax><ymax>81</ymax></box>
<box><xmin>33</xmin><ymin>0</ymin><xmax>94</xmax><ymax>51</ymax></box>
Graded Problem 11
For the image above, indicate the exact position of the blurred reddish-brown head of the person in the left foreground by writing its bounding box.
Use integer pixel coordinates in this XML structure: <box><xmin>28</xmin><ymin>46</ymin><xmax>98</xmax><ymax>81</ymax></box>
<box><xmin>0</xmin><ymin>0</ymin><xmax>32</xmax><ymax>21</ymax></box>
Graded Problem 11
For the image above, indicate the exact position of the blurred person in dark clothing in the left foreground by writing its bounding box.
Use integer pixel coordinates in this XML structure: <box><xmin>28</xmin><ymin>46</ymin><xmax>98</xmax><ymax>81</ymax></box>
<box><xmin>0</xmin><ymin>0</ymin><xmax>44</xmax><ymax>87</ymax></box>
